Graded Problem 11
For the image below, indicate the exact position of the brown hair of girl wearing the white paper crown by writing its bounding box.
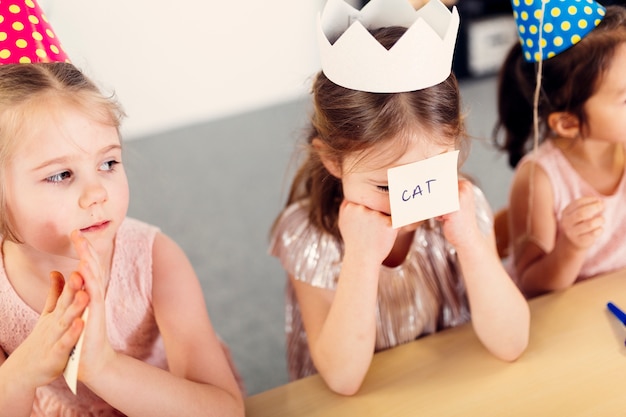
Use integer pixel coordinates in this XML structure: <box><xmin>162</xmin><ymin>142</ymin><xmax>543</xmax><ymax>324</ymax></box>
<box><xmin>276</xmin><ymin>27</ymin><xmax>467</xmax><ymax>239</ymax></box>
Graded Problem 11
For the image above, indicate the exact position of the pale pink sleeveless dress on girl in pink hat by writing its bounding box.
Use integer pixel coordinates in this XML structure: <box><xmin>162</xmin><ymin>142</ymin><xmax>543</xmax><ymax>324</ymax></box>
<box><xmin>0</xmin><ymin>219</ymin><xmax>167</xmax><ymax>417</ymax></box>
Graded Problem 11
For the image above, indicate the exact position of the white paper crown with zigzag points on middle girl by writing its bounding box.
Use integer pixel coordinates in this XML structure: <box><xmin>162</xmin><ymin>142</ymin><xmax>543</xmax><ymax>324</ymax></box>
<box><xmin>318</xmin><ymin>0</ymin><xmax>459</xmax><ymax>93</ymax></box>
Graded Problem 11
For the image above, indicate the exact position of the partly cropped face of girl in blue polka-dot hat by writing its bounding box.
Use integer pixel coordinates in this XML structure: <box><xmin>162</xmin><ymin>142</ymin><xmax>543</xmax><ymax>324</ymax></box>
<box><xmin>584</xmin><ymin>43</ymin><xmax>626</xmax><ymax>142</ymax></box>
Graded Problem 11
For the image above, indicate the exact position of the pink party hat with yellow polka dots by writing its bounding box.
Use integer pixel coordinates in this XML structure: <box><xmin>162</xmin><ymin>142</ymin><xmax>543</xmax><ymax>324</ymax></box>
<box><xmin>0</xmin><ymin>0</ymin><xmax>69</xmax><ymax>65</ymax></box>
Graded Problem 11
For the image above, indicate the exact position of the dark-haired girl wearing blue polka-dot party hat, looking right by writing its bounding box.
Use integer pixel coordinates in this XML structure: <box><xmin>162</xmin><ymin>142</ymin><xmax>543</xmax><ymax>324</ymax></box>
<box><xmin>497</xmin><ymin>0</ymin><xmax>626</xmax><ymax>296</ymax></box>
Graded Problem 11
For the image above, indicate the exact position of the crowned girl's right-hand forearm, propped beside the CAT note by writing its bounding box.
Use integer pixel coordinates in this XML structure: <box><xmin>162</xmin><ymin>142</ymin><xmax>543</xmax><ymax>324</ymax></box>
<box><xmin>442</xmin><ymin>180</ymin><xmax>530</xmax><ymax>361</ymax></box>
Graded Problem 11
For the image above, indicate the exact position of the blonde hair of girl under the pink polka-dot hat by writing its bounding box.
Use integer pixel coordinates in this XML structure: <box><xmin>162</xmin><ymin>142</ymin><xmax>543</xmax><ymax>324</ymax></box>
<box><xmin>0</xmin><ymin>63</ymin><xmax>124</xmax><ymax>241</ymax></box>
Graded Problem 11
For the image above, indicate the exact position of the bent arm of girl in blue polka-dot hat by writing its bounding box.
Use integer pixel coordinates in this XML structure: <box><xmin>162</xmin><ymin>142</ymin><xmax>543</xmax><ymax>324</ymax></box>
<box><xmin>509</xmin><ymin>162</ymin><xmax>603</xmax><ymax>296</ymax></box>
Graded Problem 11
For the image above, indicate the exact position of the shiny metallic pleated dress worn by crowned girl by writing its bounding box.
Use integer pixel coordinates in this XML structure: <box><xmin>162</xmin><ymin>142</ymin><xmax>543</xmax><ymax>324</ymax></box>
<box><xmin>270</xmin><ymin>187</ymin><xmax>493</xmax><ymax>380</ymax></box>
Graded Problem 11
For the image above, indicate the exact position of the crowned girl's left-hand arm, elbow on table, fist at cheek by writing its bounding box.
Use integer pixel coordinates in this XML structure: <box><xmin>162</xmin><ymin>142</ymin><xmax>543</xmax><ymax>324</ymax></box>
<box><xmin>290</xmin><ymin>202</ymin><xmax>397</xmax><ymax>395</ymax></box>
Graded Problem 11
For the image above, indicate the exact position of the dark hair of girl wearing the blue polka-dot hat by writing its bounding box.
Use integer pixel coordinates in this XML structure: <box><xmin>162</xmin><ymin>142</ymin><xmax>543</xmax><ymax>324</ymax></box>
<box><xmin>494</xmin><ymin>6</ymin><xmax>626</xmax><ymax>167</ymax></box>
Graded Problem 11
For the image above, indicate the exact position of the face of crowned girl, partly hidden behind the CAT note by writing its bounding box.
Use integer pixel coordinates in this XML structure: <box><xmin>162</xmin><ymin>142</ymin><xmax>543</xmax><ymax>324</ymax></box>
<box><xmin>341</xmin><ymin>132</ymin><xmax>454</xmax><ymax>224</ymax></box>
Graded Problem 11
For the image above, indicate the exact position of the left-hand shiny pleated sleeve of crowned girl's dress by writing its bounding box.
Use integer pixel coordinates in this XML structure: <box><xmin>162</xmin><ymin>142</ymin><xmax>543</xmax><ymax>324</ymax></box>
<box><xmin>269</xmin><ymin>200</ymin><xmax>343</xmax><ymax>289</ymax></box>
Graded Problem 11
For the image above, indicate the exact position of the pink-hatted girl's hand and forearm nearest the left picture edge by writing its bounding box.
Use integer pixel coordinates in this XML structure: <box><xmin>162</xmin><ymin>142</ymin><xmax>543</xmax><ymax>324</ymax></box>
<box><xmin>0</xmin><ymin>272</ymin><xmax>89</xmax><ymax>416</ymax></box>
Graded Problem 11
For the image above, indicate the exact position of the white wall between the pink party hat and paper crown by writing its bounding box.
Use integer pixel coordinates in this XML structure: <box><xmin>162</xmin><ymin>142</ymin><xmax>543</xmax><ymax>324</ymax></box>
<box><xmin>45</xmin><ymin>0</ymin><xmax>323</xmax><ymax>139</ymax></box>
